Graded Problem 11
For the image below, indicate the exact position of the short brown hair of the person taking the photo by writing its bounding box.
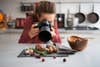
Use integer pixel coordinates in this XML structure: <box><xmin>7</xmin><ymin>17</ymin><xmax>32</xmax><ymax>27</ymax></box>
<box><xmin>35</xmin><ymin>1</ymin><xmax>55</xmax><ymax>16</ymax></box>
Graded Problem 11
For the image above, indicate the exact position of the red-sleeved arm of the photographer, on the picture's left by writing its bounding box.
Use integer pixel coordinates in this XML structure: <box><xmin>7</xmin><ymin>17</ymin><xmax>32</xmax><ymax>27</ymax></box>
<box><xmin>19</xmin><ymin>17</ymin><xmax>36</xmax><ymax>43</ymax></box>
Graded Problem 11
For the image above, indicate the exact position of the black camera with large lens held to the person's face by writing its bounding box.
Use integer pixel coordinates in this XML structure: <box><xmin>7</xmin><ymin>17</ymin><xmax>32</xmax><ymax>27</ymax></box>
<box><xmin>37</xmin><ymin>20</ymin><xmax>52</xmax><ymax>42</ymax></box>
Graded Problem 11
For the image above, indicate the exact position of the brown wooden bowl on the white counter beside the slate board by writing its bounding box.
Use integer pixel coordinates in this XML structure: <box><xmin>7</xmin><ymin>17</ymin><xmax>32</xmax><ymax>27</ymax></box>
<box><xmin>67</xmin><ymin>36</ymin><xmax>88</xmax><ymax>51</ymax></box>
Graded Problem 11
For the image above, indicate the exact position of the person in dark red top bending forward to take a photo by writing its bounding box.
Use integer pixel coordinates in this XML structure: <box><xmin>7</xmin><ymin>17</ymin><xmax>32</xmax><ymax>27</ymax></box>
<box><xmin>19</xmin><ymin>1</ymin><xmax>61</xmax><ymax>43</ymax></box>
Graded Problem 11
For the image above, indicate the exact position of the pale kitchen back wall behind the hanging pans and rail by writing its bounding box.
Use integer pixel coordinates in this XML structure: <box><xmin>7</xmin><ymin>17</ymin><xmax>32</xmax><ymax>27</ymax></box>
<box><xmin>0</xmin><ymin>0</ymin><xmax>100</xmax><ymax>27</ymax></box>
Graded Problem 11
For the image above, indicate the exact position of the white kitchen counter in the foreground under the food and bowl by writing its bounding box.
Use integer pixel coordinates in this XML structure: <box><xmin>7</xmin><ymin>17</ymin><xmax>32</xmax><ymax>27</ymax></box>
<box><xmin>0</xmin><ymin>31</ymin><xmax>100</xmax><ymax>67</ymax></box>
